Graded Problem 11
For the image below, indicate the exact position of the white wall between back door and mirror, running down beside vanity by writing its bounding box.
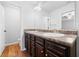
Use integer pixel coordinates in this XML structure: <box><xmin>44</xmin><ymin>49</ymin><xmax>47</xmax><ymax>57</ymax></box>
<box><xmin>20</xmin><ymin>5</ymin><xmax>34</xmax><ymax>50</ymax></box>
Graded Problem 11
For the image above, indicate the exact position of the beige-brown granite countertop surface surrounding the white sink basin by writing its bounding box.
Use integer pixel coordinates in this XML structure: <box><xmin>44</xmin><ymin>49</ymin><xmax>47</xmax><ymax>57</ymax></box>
<box><xmin>25</xmin><ymin>31</ymin><xmax>77</xmax><ymax>47</ymax></box>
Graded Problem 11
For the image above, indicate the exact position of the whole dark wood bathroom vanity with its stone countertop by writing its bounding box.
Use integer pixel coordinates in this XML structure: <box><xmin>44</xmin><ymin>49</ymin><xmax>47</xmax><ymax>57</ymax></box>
<box><xmin>25</xmin><ymin>31</ymin><xmax>77</xmax><ymax>57</ymax></box>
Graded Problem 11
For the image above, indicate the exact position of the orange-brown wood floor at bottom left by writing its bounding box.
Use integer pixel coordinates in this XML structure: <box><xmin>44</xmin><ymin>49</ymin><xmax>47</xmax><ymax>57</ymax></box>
<box><xmin>1</xmin><ymin>44</ymin><xmax>29</xmax><ymax>57</ymax></box>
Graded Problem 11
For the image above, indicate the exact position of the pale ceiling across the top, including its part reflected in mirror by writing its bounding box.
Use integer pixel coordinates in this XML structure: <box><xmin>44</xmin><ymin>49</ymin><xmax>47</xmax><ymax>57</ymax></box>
<box><xmin>1</xmin><ymin>1</ymin><xmax>73</xmax><ymax>14</ymax></box>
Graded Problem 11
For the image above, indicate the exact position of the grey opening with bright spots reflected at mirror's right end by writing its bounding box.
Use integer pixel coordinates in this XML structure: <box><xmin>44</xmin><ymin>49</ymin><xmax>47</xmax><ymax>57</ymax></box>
<box><xmin>62</xmin><ymin>10</ymin><xmax>75</xmax><ymax>30</ymax></box>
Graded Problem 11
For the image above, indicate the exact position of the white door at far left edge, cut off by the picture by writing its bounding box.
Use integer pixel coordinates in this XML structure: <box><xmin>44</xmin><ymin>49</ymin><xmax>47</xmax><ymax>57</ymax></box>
<box><xmin>0</xmin><ymin>4</ymin><xmax>5</xmax><ymax>55</ymax></box>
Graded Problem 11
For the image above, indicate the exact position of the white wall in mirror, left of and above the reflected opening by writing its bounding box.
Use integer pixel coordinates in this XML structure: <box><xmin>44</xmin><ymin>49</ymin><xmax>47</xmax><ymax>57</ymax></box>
<box><xmin>50</xmin><ymin>3</ymin><xmax>75</xmax><ymax>29</ymax></box>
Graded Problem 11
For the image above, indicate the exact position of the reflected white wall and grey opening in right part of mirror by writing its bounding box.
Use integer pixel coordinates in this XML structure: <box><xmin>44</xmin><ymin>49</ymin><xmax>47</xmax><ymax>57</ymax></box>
<box><xmin>48</xmin><ymin>2</ymin><xmax>75</xmax><ymax>30</ymax></box>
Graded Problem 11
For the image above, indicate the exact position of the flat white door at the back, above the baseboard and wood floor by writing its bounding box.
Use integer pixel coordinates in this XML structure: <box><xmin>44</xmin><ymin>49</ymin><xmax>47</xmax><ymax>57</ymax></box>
<box><xmin>5</xmin><ymin>6</ymin><xmax>21</xmax><ymax>44</ymax></box>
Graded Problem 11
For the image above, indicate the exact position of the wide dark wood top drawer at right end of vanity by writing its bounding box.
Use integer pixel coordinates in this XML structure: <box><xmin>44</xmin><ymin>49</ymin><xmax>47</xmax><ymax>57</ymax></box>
<box><xmin>45</xmin><ymin>40</ymin><xmax>68</xmax><ymax>55</ymax></box>
